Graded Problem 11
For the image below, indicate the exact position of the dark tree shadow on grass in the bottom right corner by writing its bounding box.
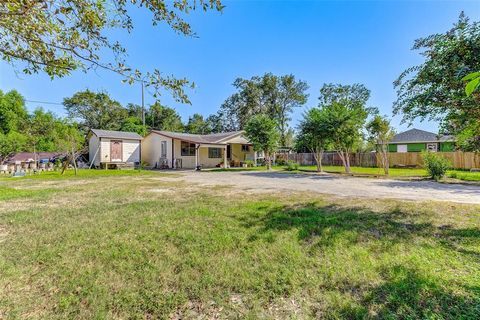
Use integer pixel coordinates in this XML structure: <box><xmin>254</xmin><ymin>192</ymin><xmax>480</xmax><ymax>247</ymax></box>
<box><xmin>340</xmin><ymin>265</ymin><xmax>480</xmax><ymax>319</ymax></box>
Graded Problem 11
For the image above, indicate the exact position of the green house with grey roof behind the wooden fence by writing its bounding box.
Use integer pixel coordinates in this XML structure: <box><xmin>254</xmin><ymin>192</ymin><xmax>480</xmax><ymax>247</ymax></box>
<box><xmin>388</xmin><ymin>129</ymin><xmax>455</xmax><ymax>152</ymax></box>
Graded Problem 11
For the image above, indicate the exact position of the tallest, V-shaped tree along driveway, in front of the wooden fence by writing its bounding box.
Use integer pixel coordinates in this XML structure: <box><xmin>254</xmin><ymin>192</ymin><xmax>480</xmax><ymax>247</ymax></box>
<box><xmin>319</xmin><ymin>84</ymin><xmax>373</xmax><ymax>173</ymax></box>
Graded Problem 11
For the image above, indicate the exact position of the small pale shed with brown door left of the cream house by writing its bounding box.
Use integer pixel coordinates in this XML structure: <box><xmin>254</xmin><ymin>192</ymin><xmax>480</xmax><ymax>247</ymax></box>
<box><xmin>87</xmin><ymin>129</ymin><xmax>143</xmax><ymax>167</ymax></box>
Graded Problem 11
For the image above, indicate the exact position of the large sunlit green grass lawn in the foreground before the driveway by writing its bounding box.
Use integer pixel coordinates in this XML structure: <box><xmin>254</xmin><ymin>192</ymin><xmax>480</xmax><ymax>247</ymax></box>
<box><xmin>0</xmin><ymin>171</ymin><xmax>480</xmax><ymax>319</ymax></box>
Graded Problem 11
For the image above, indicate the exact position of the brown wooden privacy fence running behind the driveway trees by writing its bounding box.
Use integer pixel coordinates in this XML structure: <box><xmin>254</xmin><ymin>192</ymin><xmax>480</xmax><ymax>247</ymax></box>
<box><xmin>276</xmin><ymin>151</ymin><xmax>480</xmax><ymax>169</ymax></box>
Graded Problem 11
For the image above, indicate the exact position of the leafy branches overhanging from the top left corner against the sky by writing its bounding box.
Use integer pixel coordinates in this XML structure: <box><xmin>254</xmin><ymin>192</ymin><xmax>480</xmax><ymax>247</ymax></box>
<box><xmin>0</xmin><ymin>0</ymin><xmax>223</xmax><ymax>103</ymax></box>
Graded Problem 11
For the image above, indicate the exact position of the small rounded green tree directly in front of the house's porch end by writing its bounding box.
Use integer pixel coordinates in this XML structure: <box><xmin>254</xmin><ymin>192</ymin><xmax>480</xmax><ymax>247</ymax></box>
<box><xmin>245</xmin><ymin>114</ymin><xmax>280</xmax><ymax>170</ymax></box>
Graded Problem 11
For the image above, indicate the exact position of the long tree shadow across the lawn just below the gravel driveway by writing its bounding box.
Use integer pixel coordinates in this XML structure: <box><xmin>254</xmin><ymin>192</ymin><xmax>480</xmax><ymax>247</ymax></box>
<box><xmin>237</xmin><ymin>202</ymin><xmax>480</xmax><ymax>259</ymax></box>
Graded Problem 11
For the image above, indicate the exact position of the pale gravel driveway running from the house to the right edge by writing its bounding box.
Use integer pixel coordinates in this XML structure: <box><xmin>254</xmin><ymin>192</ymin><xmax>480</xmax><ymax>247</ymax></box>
<box><xmin>173</xmin><ymin>171</ymin><xmax>480</xmax><ymax>204</ymax></box>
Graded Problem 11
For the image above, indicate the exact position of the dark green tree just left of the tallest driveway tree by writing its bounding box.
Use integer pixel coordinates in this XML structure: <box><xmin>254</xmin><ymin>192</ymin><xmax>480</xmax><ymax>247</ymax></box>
<box><xmin>296</xmin><ymin>108</ymin><xmax>331</xmax><ymax>172</ymax></box>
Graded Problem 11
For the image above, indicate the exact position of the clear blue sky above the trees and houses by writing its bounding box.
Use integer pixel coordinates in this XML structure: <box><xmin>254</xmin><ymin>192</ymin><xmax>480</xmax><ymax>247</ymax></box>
<box><xmin>0</xmin><ymin>1</ymin><xmax>480</xmax><ymax>131</ymax></box>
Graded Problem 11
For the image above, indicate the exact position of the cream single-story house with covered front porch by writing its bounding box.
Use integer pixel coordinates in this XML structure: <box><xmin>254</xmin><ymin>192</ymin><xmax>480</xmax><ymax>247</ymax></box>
<box><xmin>142</xmin><ymin>130</ymin><xmax>257</xmax><ymax>168</ymax></box>
